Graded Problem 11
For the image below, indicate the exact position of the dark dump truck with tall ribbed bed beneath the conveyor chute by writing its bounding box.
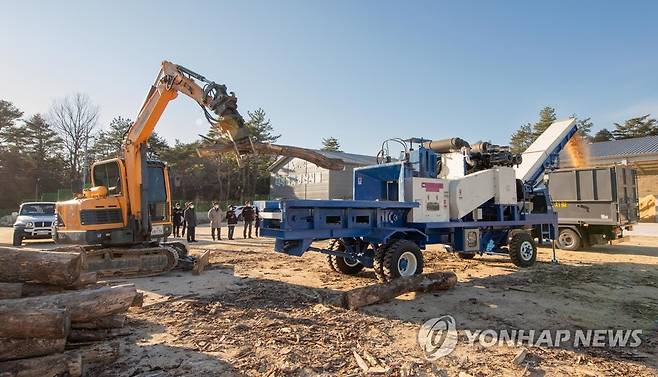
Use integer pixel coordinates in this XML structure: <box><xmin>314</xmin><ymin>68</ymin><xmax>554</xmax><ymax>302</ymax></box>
<box><xmin>548</xmin><ymin>165</ymin><xmax>639</xmax><ymax>250</ymax></box>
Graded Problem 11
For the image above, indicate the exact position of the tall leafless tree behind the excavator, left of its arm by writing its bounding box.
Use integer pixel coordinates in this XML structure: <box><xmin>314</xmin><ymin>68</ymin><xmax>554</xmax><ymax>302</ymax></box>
<box><xmin>50</xmin><ymin>93</ymin><xmax>98</xmax><ymax>190</ymax></box>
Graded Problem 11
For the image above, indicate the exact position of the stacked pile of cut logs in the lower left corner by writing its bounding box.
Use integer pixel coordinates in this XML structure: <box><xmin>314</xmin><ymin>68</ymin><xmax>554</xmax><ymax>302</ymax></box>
<box><xmin>0</xmin><ymin>247</ymin><xmax>139</xmax><ymax>377</ymax></box>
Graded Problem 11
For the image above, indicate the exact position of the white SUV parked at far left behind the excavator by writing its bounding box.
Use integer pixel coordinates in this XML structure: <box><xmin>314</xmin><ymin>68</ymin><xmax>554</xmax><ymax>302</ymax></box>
<box><xmin>13</xmin><ymin>202</ymin><xmax>57</xmax><ymax>246</ymax></box>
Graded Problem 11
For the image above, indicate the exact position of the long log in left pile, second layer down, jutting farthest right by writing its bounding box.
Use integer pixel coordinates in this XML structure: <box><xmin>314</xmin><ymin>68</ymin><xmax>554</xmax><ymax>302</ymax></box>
<box><xmin>0</xmin><ymin>284</ymin><xmax>137</xmax><ymax>323</ymax></box>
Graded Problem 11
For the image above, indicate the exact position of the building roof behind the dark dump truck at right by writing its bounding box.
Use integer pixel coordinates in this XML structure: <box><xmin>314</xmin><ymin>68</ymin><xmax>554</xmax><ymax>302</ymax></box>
<box><xmin>560</xmin><ymin>136</ymin><xmax>658</xmax><ymax>174</ymax></box>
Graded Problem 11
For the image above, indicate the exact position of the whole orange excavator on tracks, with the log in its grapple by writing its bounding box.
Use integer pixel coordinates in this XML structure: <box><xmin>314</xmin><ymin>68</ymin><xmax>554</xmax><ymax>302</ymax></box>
<box><xmin>53</xmin><ymin>61</ymin><xmax>342</xmax><ymax>276</ymax></box>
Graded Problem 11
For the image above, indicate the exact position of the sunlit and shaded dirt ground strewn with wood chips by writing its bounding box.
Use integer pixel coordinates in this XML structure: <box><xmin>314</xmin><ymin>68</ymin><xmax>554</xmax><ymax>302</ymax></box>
<box><xmin>0</xmin><ymin>228</ymin><xmax>658</xmax><ymax>377</ymax></box>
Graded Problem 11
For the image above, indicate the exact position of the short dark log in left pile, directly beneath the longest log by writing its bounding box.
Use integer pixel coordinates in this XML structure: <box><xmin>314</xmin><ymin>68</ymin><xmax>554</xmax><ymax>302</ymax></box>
<box><xmin>0</xmin><ymin>307</ymin><xmax>71</xmax><ymax>339</ymax></box>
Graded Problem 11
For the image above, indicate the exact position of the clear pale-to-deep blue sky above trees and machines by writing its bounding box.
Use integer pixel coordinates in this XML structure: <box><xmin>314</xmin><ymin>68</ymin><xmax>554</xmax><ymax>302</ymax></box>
<box><xmin>0</xmin><ymin>0</ymin><xmax>658</xmax><ymax>154</ymax></box>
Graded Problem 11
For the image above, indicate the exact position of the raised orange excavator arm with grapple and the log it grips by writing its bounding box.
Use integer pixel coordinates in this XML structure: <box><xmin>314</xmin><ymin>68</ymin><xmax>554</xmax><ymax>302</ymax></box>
<box><xmin>124</xmin><ymin>61</ymin><xmax>344</xmax><ymax>237</ymax></box>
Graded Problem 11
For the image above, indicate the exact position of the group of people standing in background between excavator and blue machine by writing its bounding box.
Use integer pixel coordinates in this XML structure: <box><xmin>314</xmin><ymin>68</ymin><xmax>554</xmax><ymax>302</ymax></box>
<box><xmin>172</xmin><ymin>202</ymin><xmax>260</xmax><ymax>242</ymax></box>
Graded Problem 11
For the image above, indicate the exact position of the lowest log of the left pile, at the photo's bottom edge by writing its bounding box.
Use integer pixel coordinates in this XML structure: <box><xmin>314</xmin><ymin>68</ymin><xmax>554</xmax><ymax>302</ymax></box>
<box><xmin>0</xmin><ymin>353</ymin><xmax>82</xmax><ymax>377</ymax></box>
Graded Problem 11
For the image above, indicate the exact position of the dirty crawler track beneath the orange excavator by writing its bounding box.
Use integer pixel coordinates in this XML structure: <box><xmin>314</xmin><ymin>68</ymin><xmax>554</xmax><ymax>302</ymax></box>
<box><xmin>84</xmin><ymin>245</ymin><xmax>180</xmax><ymax>277</ymax></box>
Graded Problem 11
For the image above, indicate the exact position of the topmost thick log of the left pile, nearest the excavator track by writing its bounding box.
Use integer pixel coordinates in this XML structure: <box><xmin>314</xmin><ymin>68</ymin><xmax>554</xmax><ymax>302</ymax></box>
<box><xmin>0</xmin><ymin>247</ymin><xmax>83</xmax><ymax>286</ymax></box>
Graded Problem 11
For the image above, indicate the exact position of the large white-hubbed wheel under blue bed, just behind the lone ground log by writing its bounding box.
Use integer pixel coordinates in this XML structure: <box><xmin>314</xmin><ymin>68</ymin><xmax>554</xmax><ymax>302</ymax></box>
<box><xmin>383</xmin><ymin>240</ymin><xmax>423</xmax><ymax>281</ymax></box>
